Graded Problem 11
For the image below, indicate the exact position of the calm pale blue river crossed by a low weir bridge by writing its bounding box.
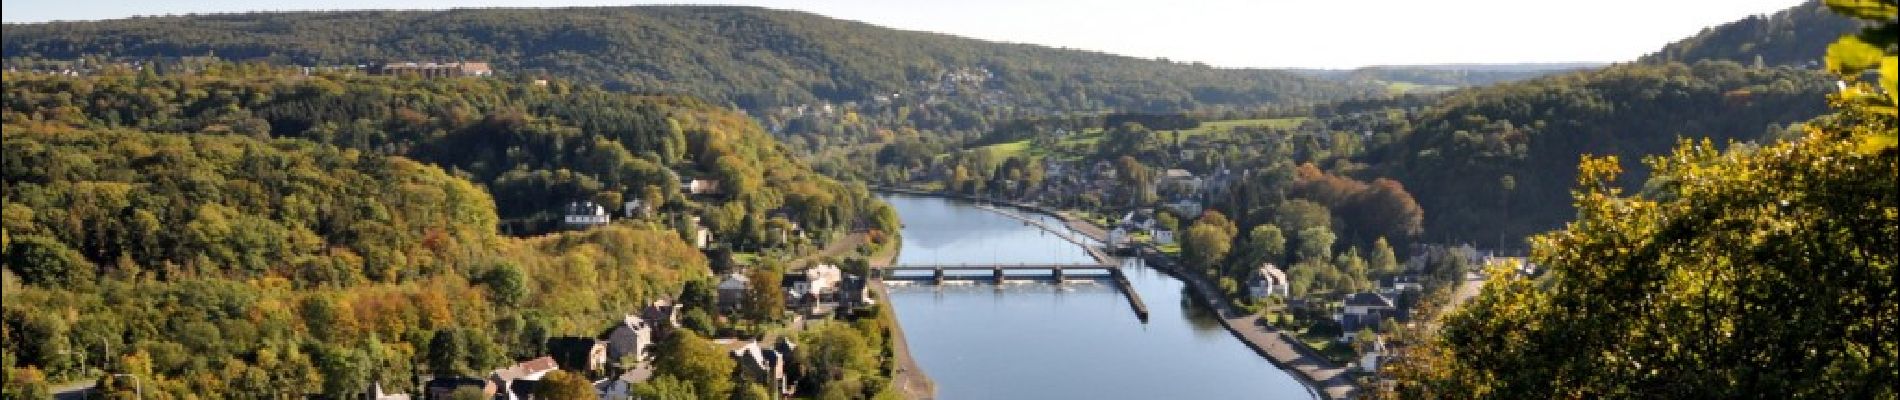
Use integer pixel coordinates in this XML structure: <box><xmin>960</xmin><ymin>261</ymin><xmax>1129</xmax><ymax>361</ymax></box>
<box><xmin>884</xmin><ymin>195</ymin><xmax>1313</xmax><ymax>400</ymax></box>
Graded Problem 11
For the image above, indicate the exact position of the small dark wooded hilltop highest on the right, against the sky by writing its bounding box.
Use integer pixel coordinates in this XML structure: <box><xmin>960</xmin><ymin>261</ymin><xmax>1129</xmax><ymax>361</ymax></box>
<box><xmin>1642</xmin><ymin>0</ymin><xmax>1862</xmax><ymax>66</ymax></box>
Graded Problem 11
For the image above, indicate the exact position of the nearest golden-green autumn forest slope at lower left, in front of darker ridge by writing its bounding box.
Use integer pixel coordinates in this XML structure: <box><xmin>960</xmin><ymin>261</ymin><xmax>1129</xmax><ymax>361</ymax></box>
<box><xmin>4</xmin><ymin>123</ymin><xmax>709</xmax><ymax>398</ymax></box>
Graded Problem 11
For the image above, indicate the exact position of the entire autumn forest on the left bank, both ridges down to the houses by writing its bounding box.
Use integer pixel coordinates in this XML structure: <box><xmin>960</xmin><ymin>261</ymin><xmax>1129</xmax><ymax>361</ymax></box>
<box><xmin>0</xmin><ymin>64</ymin><xmax>897</xmax><ymax>398</ymax></box>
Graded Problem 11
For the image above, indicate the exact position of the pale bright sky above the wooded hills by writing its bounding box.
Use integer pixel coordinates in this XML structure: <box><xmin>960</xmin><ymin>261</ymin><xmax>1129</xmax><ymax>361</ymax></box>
<box><xmin>0</xmin><ymin>0</ymin><xmax>1799</xmax><ymax>68</ymax></box>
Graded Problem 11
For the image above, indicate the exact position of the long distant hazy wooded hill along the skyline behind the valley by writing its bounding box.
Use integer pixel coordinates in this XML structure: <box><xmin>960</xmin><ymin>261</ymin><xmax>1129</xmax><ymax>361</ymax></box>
<box><xmin>0</xmin><ymin>6</ymin><xmax>1376</xmax><ymax>112</ymax></box>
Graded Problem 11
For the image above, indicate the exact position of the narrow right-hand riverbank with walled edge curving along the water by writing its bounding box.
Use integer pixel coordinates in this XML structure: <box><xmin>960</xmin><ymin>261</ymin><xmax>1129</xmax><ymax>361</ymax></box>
<box><xmin>876</xmin><ymin>188</ymin><xmax>1359</xmax><ymax>400</ymax></box>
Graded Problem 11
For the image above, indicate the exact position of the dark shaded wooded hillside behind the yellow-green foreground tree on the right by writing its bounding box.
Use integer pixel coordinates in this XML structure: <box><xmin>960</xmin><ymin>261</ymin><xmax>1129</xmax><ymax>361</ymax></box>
<box><xmin>1372</xmin><ymin>61</ymin><xmax>1832</xmax><ymax>245</ymax></box>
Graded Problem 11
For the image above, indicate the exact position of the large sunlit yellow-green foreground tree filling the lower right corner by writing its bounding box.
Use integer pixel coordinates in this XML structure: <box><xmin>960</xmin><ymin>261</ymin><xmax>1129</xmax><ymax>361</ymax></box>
<box><xmin>1397</xmin><ymin>100</ymin><xmax>1900</xmax><ymax>398</ymax></box>
